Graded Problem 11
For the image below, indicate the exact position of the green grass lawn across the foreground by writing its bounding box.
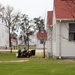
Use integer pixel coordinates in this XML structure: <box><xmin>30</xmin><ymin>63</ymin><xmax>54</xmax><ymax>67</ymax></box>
<box><xmin>0</xmin><ymin>52</ymin><xmax>75</xmax><ymax>75</ymax></box>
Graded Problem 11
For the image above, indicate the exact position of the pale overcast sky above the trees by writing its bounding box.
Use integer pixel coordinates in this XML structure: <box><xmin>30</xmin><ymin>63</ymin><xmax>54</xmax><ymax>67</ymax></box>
<box><xmin>0</xmin><ymin>0</ymin><xmax>53</xmax><ymax>18</ymax></box>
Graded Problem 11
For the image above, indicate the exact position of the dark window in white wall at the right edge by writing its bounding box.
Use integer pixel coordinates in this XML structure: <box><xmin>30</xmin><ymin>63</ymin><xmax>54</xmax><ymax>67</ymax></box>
<box><xmin>69</xmin><ymin>23</ymin><xmax>75</xmax><ymax>41</ymax></box>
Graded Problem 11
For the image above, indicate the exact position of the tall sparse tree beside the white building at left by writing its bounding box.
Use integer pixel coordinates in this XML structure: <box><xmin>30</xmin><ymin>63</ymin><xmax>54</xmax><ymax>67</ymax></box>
<box><xmin>0</xmin><ymin>5</ymin><xmax>18</xmax><ymax>47</ymax></box>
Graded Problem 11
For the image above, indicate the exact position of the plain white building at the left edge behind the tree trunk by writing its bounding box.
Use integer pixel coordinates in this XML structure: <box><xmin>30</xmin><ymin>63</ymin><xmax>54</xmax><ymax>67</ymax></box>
<box><xmin>0</xmin><ymin>18</ymin><xmax>9</xmax><ymax>48</ymax></box>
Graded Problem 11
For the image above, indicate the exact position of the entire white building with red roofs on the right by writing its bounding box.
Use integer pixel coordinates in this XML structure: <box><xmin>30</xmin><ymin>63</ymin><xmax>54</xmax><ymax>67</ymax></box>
<box><xmin>47</xmin><ymin>0</ymin><xmax>75</xmax><ymax>58</ymax></box>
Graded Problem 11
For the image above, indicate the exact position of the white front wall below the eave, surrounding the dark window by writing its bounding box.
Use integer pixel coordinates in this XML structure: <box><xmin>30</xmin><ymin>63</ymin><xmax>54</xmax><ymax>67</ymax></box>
<box><xmin>56</xmin><ymin>21</ymin><xmax>75</xmax><ymax>58</ymax></box>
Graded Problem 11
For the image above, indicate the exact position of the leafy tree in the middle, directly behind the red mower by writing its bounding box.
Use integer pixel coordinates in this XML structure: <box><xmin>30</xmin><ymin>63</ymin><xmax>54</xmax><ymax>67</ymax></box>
<box><xmin>19</xmin><ymin>14</ymin><xmax>33</xmax><ymax>50</ymax></box>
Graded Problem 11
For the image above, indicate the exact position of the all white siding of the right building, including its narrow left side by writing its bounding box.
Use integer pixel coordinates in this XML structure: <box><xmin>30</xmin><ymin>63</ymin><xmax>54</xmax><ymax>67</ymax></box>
<box><xmin>47</xmin><ymin>2</ymin><xmax>75</xmax><ymax>58</ymax></box>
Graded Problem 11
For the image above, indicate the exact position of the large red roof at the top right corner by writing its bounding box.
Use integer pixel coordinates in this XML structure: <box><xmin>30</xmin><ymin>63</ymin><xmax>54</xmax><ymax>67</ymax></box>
<box><xmin>54</xmin><ymin>0</ymin><xmax>75</xmax><ymax>19</ymax></box>
